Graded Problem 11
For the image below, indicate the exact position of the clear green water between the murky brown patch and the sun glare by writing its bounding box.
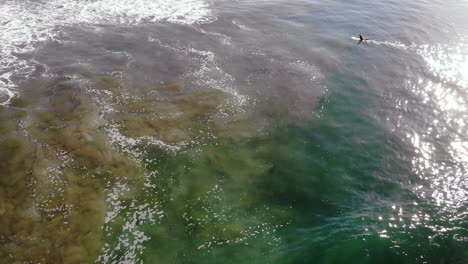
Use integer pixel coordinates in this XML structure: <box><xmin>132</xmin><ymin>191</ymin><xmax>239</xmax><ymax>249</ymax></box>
<box><xmin>98</xmin><ymin>74</ymin><xmax>468</xmax><ymax>263</ymax></box>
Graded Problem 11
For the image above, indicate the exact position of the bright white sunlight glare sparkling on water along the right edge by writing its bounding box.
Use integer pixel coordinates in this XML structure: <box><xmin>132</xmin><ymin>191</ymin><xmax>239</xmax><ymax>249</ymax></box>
<box><xmin>407</xmin><ymin>39</ymin><xmax>468</xmax><ymax>240</ymax></box>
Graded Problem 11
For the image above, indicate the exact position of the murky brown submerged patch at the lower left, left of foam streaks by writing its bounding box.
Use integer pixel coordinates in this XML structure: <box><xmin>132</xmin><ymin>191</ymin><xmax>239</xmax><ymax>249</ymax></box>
<box><xmin>0</xmin><ymin>81</ymin><xmax>144</xmax><ymax>263</ymax></box>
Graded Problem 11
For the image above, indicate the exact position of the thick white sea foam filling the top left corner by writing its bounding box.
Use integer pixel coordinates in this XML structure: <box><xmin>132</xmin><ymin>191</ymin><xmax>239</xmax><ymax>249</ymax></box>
<box><xmin>0</xmin><ymin>0</ymin><xmax>213</xmax><ymax>104</ymax></box>
